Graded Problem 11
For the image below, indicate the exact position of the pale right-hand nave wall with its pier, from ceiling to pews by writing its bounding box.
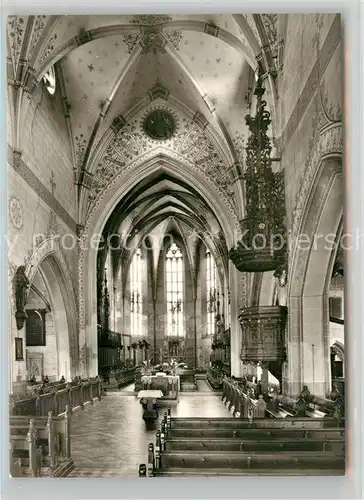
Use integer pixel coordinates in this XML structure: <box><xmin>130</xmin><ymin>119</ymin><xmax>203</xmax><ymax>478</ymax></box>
<box><xmin>278</xmin><ymin>14</ymin><xmax>343</xmax><ymax>396</ymax></box>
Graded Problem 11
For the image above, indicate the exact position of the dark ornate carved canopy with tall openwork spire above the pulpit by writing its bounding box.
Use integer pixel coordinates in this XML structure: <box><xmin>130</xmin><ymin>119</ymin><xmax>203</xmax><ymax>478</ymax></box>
<box><xmin>229</xmin><ymin>71</ymin><xmax>286</xmax><ymax>272</ymax></box>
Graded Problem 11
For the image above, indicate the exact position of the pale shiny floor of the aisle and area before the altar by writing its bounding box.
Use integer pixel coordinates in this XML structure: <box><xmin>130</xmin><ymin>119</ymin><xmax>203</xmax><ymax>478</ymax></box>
<box><xmin>69</xmin><ymin>381</ymin><xmax>230</xmax><ymax>477</ymax></box>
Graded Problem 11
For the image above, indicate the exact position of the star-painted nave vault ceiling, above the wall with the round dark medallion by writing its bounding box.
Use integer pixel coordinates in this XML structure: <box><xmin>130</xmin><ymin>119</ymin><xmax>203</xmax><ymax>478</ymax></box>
<box><xmin>8</xmin><ymin>14</ymin><xmax>264</xmax><ymax>169</ymax></box>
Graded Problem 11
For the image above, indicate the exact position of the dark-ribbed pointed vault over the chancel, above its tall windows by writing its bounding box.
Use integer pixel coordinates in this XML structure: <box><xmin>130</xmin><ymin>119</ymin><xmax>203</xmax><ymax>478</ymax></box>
<box><xmin>104</xmin><ymin>171</ymin><xmax>227</xmax><ymax>280</ymax></box>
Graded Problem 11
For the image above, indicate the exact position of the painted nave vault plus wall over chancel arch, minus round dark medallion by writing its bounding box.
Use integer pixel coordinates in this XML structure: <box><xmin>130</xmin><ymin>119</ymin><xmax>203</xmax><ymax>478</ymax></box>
<box><xmin>7</xmin><ymin>14</ymin><xmax>276</xmax><ymax>230</ymax></box>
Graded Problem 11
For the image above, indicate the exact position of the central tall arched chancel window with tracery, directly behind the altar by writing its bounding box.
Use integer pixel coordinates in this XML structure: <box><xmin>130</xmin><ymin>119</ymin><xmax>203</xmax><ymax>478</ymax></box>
<box><xmin>166</xmin><ymin>243</ymin><xmax>184</xmax><ymax>337</ymax></box>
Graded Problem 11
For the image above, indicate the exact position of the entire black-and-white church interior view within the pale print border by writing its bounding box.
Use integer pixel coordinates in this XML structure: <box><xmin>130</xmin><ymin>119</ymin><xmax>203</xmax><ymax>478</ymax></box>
<box><xmin>7</xmin><ymin>13</ymin><xmax>345</xmax><ymax>477</ymax></box>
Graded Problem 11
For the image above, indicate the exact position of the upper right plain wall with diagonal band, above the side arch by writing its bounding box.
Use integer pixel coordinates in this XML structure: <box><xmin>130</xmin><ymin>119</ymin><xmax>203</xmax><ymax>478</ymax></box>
<box><xmin>278</xmin><ymin>14</ymin><xmax>343</xmax><ymax>221</ymax></box>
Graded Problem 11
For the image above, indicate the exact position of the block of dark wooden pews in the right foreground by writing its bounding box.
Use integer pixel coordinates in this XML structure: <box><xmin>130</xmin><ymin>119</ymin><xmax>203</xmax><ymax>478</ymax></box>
<box><xmin>144</xmin><ymin>409</ymin><xmax>345</xmax><ymax>477</ymax></box>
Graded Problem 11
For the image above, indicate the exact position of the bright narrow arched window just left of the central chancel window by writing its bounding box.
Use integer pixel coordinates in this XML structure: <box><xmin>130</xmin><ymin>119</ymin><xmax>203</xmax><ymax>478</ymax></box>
<box><xmin>130</xmin><ymin>249</ymin><xmax>143</xmax><ymax>335</ymax></box>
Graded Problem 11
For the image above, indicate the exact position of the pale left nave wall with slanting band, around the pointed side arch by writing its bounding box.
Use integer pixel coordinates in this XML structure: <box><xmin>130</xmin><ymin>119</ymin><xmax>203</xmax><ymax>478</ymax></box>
<box><xmin>7</xmin><ymin>80</ymin><xmax>78</xmax><ymax>381</ymax></box>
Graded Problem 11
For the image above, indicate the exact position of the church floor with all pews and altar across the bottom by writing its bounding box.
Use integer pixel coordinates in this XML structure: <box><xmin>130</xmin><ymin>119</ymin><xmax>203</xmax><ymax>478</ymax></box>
<box><xmin>10</xmin><ymin>368</ymin><xmax>345</xmax><ymax>477</ymax></box>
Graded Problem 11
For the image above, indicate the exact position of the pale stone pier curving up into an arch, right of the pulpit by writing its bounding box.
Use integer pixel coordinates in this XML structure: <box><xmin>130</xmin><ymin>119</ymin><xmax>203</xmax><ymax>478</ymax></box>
<box><xmin>285</xmin><ymin>156</ymin><xmax>344</xmax><ymax>396</ymax></box>
